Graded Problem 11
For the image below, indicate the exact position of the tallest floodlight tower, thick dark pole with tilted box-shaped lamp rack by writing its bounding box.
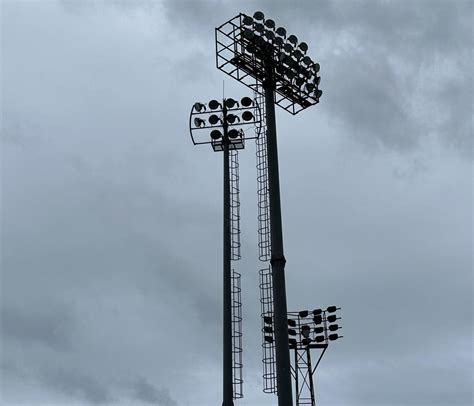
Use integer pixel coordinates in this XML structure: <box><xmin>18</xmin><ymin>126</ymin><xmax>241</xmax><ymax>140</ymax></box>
<box><xmin>216</xmin><ymin>11</ymin><xmax>322</xmax><ymax>406</ymax></box>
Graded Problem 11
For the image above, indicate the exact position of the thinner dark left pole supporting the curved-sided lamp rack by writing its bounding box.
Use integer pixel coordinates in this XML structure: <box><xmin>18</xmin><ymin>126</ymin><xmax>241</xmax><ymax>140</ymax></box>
<box><xmin>222</xmin><ymin>100</ymin><xmax>234</xmax><ymax>406</ymax></box>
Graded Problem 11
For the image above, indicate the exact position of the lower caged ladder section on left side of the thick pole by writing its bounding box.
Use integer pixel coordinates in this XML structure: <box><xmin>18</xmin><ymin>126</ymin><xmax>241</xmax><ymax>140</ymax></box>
<box><xmin>259</xmin><ymin>266</ymin><xmax>277</xmax><ymax>394</ymax></box>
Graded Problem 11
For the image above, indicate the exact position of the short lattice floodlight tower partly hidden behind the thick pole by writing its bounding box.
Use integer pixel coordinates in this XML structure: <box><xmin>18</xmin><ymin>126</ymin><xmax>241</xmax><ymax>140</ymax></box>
<box><xmin>288</xmin><ymin>306</ymin><xmax>342</xmax><ymax>406</ymax></box>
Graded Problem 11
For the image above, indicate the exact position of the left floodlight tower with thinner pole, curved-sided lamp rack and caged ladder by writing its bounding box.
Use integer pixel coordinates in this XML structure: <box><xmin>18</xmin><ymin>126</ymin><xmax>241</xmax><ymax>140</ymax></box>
<box><xmin>189</xmin><ymin>97</ymin><xmax>261</xmax><ymax>406</ymax></box>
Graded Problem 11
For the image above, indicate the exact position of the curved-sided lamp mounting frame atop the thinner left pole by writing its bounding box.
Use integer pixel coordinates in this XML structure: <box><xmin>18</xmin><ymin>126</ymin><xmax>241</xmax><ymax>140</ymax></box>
<box><xmin>189</xmin><ymin>97</ymin><xmax>263</xmax><ymax>152</ymax></box>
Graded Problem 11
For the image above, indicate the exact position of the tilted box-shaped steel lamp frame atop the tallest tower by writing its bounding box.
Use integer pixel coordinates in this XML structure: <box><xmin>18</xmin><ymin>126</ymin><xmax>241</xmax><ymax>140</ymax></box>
<box><xmin>215</xmin><ymin>13</ymin><xmax>322</xmax><ymax>114</ymax></box>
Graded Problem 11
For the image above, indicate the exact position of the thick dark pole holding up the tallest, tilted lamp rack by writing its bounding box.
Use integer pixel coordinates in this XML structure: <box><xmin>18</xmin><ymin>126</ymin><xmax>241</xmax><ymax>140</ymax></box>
<box><xmin>263</xmin><ymin>77</ymin><xmax>293</xmax><ymax>406</ymax></box>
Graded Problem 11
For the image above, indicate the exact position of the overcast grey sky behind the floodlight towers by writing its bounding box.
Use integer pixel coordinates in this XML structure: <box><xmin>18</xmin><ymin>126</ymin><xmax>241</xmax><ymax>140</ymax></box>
<box><xmin>0</xmin><ymin>0</ymin><xmax>473</xmax><ymax>406</ymax></box>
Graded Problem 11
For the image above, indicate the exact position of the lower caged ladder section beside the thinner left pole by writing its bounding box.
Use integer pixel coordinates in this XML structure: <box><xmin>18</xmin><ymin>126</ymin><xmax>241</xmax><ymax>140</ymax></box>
<box><xmin>232</xmin><ymin>270</ymin><xmax>244</xmax><ymax>399</ymax></box>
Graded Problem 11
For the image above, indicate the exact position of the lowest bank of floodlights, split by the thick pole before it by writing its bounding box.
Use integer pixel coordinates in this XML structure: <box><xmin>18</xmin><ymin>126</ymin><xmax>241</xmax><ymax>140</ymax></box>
<box><xmin>263</xmin><ymin>306</ymin><xmax>342</xmax><ymax>348</ymax></box>
